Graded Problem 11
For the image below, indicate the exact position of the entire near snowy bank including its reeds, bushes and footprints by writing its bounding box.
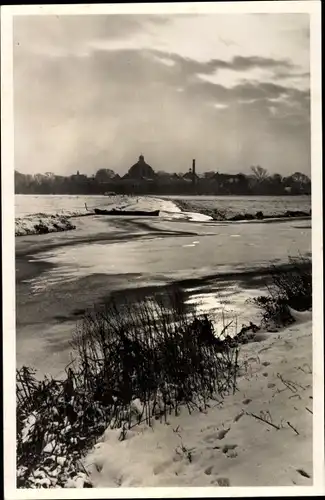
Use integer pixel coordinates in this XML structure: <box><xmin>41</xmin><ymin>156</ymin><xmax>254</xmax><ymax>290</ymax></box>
<box><xmin>16</xmin><ymin>259</ymin><xmax>313</xmax><ymax>488</ymax></box>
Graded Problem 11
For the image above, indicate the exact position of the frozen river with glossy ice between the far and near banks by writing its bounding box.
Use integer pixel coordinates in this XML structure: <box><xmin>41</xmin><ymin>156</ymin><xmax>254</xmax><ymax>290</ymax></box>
<box><xmin>16</xmin><ymin>209</ymin><xmax>311</xmax><ymax>375</ymax></box>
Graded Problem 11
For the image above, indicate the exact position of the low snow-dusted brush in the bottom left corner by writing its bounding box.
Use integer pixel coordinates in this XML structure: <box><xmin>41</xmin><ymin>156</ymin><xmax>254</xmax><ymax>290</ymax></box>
<box><xmin>16</xmin><ymin>367</ymin><xmax>94</xmax><ymax>488</ymax></box>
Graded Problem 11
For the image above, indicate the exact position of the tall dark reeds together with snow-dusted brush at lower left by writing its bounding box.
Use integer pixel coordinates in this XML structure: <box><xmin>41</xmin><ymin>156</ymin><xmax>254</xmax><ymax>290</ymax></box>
<box><xmin>17</xmin><ymin>292</ymin><xmax>238</xmax><ymax>488</ymax></box>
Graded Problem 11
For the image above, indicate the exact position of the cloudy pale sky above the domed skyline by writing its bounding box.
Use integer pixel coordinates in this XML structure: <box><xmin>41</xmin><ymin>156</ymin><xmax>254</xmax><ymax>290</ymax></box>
<box><xmin>13</xmin><ymin>14</ymin><xmax>311</xmax><ymax>175</ymax></box>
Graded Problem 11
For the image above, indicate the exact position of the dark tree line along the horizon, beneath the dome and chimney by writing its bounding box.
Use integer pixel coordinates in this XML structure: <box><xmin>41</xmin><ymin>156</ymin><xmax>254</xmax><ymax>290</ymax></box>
<box><xmin>15</xmin><ymin>165</ymin><xmax>311</xmax><ymax>195</ymax></box>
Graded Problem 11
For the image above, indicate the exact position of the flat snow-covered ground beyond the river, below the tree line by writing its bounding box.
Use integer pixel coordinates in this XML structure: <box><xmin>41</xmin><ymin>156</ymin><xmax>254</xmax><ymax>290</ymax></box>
<box><xmin>15</xmin><ymin>195</ymin><xmax>310</xmax><ymax>236</ymax></box>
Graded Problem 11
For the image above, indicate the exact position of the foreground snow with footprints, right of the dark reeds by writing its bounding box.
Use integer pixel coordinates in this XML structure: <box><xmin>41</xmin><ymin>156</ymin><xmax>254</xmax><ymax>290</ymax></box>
<box><xmin>84</xmin><ymin>314</ymin><xmax>313</xmax><ymax>488</ymax></box>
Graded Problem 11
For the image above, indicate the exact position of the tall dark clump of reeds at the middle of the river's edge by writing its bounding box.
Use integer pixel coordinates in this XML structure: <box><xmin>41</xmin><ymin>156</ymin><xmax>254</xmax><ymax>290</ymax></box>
<box><xmin>74</xmin><ymin>292</ymin><xmax>236</xmax><ymax>427</ymax></box>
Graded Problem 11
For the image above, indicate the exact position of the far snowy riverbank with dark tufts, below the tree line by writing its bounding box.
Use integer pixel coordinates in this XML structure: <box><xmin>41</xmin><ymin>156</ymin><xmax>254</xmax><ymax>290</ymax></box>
<box><xmin>15</xmin><ymin>195</ymin><xmax>311</xmax><ymax>236</ymax></box>
